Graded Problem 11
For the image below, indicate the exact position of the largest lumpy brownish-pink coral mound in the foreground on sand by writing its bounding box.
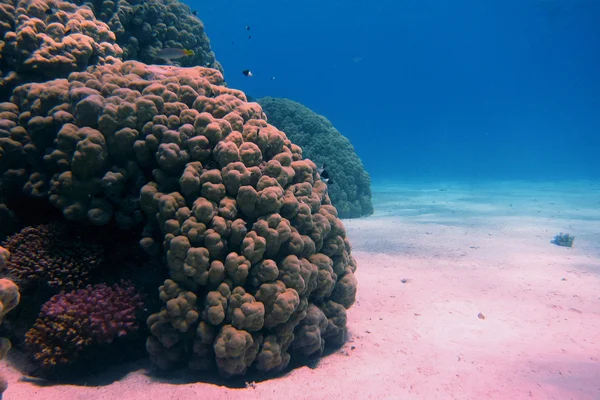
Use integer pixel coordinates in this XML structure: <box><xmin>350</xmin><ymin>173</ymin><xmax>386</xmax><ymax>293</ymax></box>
<box><xmin>0</xmin><ymin>57</ymin><xmax>356</xmax><ymax>376</ymax></box>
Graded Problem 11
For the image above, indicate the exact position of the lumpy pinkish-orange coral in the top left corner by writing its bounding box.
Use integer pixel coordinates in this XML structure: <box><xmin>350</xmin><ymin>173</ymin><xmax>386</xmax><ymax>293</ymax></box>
<box><xmin>0</xmin><ymin>0</ymin><xmax>123</xmax><ymax>99</ymax></box>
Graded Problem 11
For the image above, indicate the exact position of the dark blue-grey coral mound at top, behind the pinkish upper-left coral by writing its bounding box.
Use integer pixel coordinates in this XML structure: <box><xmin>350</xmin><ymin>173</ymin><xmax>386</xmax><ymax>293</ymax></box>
<box><xmin>65</xmin><ymin>0</ymin><xmax>223</xmax><ymax>72</ymax></box>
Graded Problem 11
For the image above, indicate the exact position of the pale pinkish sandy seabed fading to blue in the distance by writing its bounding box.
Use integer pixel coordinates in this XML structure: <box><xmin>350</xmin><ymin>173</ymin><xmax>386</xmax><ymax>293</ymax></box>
<box><xmin>3</xmin><ymin>181</ymin><xmax>600</xmax><ymax>400</ymax></box>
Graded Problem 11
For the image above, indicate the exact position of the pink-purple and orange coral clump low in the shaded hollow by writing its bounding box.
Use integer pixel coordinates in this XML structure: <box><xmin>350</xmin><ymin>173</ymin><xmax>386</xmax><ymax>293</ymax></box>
<box><xmin>25</xmin><ymin>282</ymin><xmax>144</xmax><ymax>374</ymax></box>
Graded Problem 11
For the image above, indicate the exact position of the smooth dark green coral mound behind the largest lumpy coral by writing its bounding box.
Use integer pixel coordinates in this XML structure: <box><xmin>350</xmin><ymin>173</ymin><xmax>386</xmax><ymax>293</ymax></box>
<box><xmin>257</xmin><ymin>97</ymin><xmax>373</xmax><ymax>218</ymax></box>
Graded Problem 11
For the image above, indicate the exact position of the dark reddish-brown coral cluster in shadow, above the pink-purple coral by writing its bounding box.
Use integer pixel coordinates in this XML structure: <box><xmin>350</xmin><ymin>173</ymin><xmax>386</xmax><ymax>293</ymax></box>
<box><xmin>0</xmin><ymin>222</ymin><xmax>105</xmax><ymax>292</ymax></box>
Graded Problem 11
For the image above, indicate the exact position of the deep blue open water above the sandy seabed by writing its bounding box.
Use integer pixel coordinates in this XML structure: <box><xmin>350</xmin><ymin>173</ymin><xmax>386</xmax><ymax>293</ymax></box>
<box><xmin>186</xmin><ymin>0</ymin><xmax>600</xmax><ymax>181</ymax></box>
